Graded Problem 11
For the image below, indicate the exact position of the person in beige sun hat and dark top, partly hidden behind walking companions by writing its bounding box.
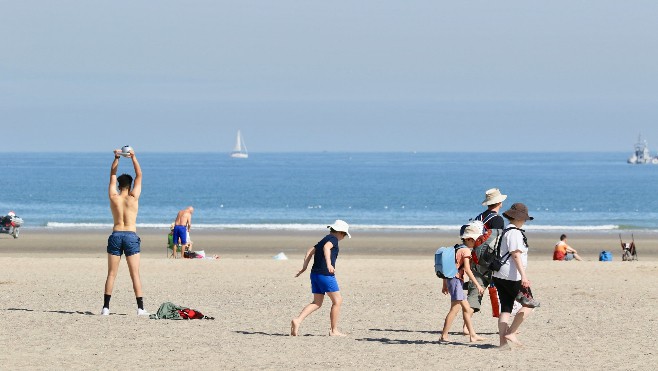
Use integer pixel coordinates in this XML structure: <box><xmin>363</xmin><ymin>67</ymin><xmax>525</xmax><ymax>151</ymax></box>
<box><xmin>463</xmin><ymin>188</ymin><xmax>507</xmax><ymax>335</ymax></box>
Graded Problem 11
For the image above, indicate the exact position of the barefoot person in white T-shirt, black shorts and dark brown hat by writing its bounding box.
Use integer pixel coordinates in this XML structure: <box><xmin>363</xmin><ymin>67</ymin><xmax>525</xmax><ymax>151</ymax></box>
<box><xmin>493</xmin><ymin>203</ymin><xmax>539</xmax><ymax>347</ymax></box>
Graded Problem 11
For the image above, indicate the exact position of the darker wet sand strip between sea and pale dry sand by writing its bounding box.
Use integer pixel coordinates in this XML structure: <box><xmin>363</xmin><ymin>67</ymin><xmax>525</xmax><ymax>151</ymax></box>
<box><xmin>0</xmin><ymin>228</ymin><xmax>658</xmax><ymax>261</ymax></box>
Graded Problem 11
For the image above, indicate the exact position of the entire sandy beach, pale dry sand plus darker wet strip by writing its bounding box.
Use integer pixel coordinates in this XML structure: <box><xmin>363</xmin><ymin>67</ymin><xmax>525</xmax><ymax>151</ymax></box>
<box><xmin>0</xmin><ymin>229</ymin><xmax>658</xmax><ymax>370</ymax></box>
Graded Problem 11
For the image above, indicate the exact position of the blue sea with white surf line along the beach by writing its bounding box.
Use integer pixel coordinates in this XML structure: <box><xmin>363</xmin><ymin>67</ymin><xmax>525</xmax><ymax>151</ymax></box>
<box><xmin>0</xmin><ymin>152</ymin><xmax>658</xmax><ymax>233</ymax></box>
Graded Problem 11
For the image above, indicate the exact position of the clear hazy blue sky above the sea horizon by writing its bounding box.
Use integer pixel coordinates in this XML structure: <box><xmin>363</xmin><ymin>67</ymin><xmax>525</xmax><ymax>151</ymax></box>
<box><xmin>0</xmin><ymin>0</ymin><xmax>658</xmax><ymax>153</ymax></box>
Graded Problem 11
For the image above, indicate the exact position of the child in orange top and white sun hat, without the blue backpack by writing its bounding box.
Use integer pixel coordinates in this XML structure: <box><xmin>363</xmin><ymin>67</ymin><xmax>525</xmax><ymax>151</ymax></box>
<box><xmin>441</xmin><ymin>222</ymin><xmax>486</xmax><ymax>342</ymax></box>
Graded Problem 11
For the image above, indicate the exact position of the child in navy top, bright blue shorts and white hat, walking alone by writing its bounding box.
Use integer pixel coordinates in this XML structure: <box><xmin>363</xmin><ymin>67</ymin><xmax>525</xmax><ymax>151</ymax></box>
<box><xmin>290</xmin><ymin>220</ymin><xmax>352</xmax><ymax>336</ymax></box>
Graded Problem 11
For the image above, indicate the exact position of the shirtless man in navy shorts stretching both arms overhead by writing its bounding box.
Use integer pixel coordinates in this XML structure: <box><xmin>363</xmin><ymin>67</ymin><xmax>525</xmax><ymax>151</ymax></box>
<box><xmin>101</xmin><ymin>149</ymin><xmax>148</xmax><ymax>316</ymax></box>
